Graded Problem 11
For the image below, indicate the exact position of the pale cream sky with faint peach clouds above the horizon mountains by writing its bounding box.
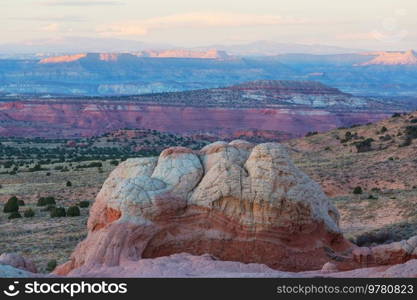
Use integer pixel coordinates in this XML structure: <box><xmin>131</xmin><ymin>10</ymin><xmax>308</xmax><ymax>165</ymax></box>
<box><xmin>0</xmin><ymin>0</ymin><xmax>417</xmax><ymax>50</ymax></box>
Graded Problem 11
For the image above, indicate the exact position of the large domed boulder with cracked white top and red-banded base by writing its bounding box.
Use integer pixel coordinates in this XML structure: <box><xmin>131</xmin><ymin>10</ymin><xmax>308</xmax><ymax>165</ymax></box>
<box><xmin>55</xmin><ymin>140</ymin><xmax>351</xmax><ymax>275</ymax></box>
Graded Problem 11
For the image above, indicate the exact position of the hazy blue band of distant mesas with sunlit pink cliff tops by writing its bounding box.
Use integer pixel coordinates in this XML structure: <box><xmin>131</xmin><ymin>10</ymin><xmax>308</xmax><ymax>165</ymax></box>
<box><xmin>0</xmin><ymin>49</ymin><xmax>417</xmax><ymax>96</ymax></box>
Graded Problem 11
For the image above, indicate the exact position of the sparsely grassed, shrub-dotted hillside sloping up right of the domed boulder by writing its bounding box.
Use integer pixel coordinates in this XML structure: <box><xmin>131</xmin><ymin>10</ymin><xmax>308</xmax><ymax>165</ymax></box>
<box><xmin>286</xmin><ymin>112</ymin><xmax>417</xmax><ymax>236</ymax></box>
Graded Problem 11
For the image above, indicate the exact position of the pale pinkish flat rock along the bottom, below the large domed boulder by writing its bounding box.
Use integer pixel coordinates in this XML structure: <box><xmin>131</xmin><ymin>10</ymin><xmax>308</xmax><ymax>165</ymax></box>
<box><xmin>62</xmin><ymin>253</ymin><xmax>417</xmax><ymax>278</ymax></box>
